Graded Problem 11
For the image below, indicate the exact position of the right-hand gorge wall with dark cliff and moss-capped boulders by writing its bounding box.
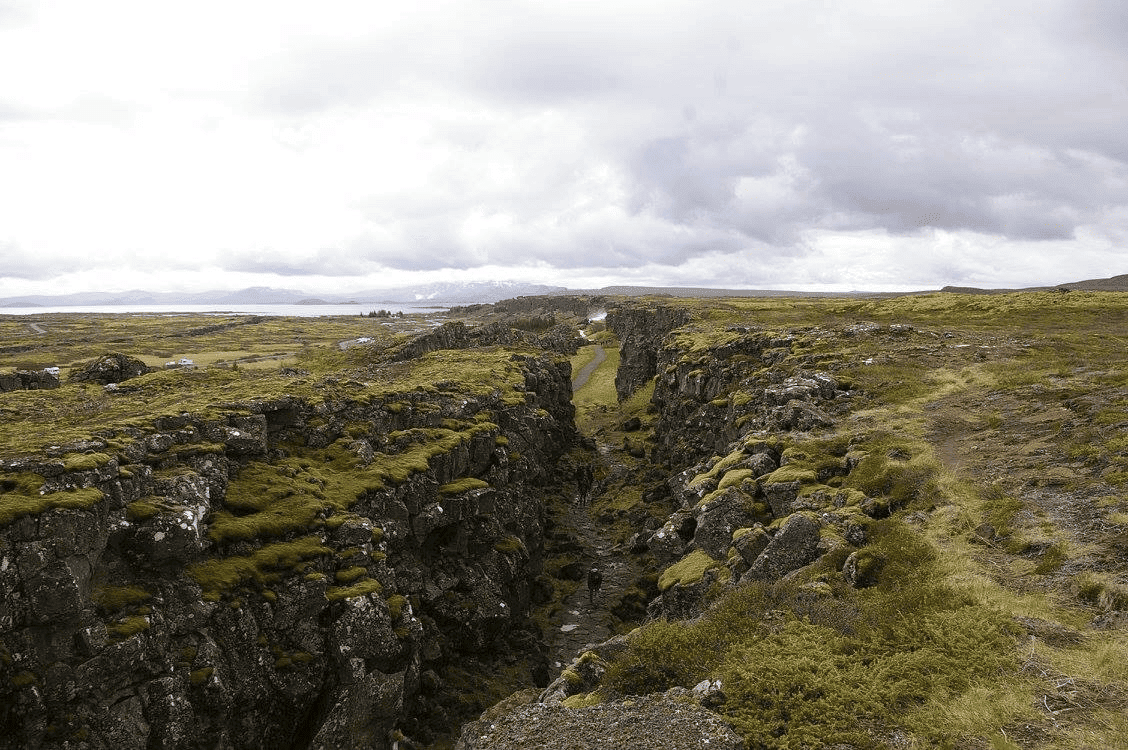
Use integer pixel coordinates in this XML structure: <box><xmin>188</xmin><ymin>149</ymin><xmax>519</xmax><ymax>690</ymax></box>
<box><xmin>608</xmin><ymin>308</ymin><xmax>861</xmax><ymax>618</ymax></box>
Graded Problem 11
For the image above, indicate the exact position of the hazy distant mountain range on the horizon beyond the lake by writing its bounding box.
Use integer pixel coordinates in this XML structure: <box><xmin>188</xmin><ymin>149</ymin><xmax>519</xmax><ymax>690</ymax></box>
<box><xmin>0</xmin><ymin>281</ymin><xmax>565</xmax><ymax>308</ymax></box>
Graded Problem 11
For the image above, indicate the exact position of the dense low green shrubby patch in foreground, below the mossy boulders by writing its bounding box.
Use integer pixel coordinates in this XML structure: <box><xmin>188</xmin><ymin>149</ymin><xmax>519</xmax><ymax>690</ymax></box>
<box><xmin>603</xmin><ymin>521</ymin><xmax>1015</xmax><ymax>748</ymax></box>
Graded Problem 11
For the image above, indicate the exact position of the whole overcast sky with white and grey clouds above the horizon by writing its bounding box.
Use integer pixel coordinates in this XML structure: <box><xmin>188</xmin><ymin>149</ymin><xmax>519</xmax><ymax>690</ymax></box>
<box><xmin>0</xmin><ymin>0</ymin><xmax>1128</xmax><ymax>297</ymax></box>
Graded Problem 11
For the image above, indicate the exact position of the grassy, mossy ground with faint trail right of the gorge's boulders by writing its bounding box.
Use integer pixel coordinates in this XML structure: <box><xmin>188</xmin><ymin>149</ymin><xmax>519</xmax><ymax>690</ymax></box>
<box><xmin>573</xmin><ymin>292</ymin><xmax>1128</xmax><ymax>749</ymax></box>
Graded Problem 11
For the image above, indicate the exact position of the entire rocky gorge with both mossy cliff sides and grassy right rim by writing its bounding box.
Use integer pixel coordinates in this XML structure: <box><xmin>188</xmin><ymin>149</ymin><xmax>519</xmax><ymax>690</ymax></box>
<box><xmin>0</xmin><ymin>294</ymin><xmax>1128</xmax><ymax>750</ymax></box>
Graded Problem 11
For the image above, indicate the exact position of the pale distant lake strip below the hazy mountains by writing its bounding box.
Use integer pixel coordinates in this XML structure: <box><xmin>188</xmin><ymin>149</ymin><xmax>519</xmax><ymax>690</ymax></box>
<box><xmin>0</xmin><ymin>302</ymin><xmax>473</xmax><ymax>318</ymax></box>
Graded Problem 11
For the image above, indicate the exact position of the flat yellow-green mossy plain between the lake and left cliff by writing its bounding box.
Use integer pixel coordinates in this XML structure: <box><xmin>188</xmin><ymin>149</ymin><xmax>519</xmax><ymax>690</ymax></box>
<box><xmin>0</xmin><ymin>315</ymin><xmax>536</xmax><ymax>461</ymax></box>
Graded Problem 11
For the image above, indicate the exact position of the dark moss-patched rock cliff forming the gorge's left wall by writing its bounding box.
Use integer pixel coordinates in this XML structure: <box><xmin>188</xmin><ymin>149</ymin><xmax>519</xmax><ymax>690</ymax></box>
<box><xmin>0</xmin><ymin>347</ymin><xmax>575</xmax><ymax>749</ymax></box>
